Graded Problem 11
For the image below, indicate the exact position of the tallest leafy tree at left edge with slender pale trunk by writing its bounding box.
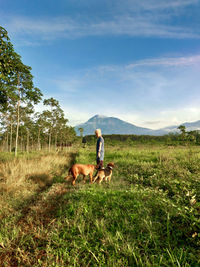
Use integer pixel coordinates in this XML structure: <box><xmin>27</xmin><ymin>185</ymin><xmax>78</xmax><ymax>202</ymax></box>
<box><xmin>0</xmin><ymin>27</ymin><xmax>42</xmax><ymax>155</ymax></box>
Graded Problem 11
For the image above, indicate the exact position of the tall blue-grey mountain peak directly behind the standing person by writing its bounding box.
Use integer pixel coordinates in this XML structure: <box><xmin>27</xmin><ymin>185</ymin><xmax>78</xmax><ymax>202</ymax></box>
<box><xmin>75</xmin><ymin>115</ymin><xmax>162</xmax><ymax>135</ymax></box>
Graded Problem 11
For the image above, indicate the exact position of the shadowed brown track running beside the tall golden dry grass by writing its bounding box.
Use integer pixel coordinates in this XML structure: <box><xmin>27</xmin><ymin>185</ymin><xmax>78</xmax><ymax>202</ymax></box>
<box><xmin>0</xmin><ymin>152</ymin><xmax>75</xmax><ymax>267</ymax></box>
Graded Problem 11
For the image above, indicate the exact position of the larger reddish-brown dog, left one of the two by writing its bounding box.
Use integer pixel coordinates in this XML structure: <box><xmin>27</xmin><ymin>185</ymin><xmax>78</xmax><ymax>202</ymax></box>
<box><xmin>66</xmin><ymin>164</ymin><xmax>96</xmax><ymax>185</ymax></box>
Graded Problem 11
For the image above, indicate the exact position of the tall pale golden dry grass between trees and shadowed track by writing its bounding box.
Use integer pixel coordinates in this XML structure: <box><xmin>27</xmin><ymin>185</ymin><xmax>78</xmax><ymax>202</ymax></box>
<box><xmin>0</xmin><ymin>153</ymin><xmax>74</xmax><ymax>218</ymax></box>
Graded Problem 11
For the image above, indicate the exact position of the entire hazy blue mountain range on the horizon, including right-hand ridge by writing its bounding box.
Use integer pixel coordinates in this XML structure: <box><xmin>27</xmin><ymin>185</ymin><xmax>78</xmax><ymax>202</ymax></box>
<box><xmin>75</xmin><ymin>115</ymin><xmax>200</xmax><ymax>135</ymax></box>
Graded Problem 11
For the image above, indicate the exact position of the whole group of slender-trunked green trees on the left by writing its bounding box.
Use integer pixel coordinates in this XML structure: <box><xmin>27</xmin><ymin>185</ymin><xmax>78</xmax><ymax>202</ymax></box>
<box><xmin>0</xmin><ymin>26</ymin><xmax>76</xmax><ymax>155</ymax></box>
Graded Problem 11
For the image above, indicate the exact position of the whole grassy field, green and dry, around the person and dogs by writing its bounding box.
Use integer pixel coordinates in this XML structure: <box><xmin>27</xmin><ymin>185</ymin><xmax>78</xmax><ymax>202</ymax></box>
<box><xmin>0</xmin><ymin>146</ymin><xmax>200</xmax><ymax>266</ymax></box>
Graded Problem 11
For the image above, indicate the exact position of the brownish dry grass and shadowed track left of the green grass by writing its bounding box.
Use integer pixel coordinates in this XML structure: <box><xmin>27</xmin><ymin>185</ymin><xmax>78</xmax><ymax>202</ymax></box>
<box><xmin>0</xmin><ymin>152</ymin><xmax>74</xmax><ymax>266</ymax></box>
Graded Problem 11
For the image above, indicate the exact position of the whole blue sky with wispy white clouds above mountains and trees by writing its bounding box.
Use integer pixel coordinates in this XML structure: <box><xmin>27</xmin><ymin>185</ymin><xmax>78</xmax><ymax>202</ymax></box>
<box><xmin>0</xmin><ymin>0</ymin><xmax>200</xmax><ymax>129</ymax></box>
